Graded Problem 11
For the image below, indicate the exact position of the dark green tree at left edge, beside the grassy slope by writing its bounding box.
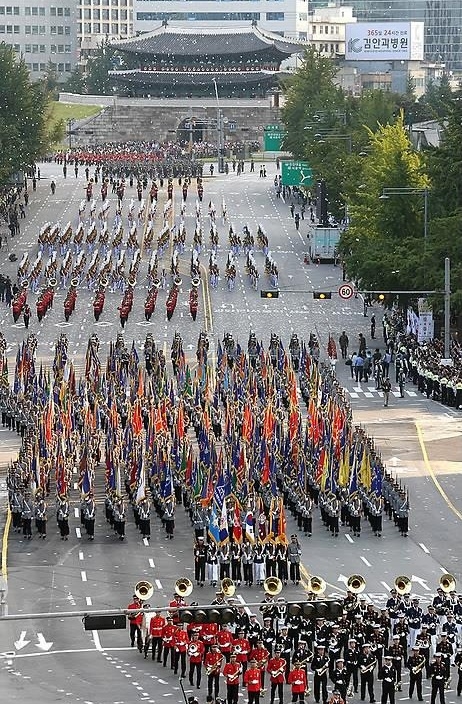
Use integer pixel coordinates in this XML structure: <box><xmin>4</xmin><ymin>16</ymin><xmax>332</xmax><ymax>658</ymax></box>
<box><xmin>0</xmin><ymin>43</ymin><xmax>48</xmax><ymax>184</ymax></box>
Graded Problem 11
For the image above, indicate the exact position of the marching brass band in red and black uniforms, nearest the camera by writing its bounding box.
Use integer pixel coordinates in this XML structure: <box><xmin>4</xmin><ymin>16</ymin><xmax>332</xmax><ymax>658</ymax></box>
<box><xmin>127</xmin><ymin>575</ymin><xmax>462</xmax><ymax>704</ymax></box>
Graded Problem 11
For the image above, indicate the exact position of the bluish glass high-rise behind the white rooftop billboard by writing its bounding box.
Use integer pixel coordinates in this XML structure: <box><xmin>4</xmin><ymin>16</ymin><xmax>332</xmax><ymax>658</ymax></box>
<box><xmin>318</xmin><ymin>0</ymin><xmax>462</xmax><ymax>71</ymax></box>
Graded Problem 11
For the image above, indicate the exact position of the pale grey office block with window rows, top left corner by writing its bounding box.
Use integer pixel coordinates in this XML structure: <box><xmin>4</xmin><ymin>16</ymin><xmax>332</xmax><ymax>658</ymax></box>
<box><xmin>0</xmin><ymin>0</ymin><xmax>77</xmax><ymax>82</ymax></box>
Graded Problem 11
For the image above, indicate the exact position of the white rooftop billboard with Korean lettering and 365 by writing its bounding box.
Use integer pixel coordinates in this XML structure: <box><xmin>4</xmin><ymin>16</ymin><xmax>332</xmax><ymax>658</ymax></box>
<box><xmin>345</xmin><ymin>22</ymin><xmax>424</xmax><ymax>61</ymax></box>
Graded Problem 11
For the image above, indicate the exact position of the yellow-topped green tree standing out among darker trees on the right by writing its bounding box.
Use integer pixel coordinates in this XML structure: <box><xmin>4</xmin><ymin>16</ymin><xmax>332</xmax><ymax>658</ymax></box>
<box><xmin>340</xmin><ymin>114</ymin><xmax>428</xmax><ymax>290</ymax></box>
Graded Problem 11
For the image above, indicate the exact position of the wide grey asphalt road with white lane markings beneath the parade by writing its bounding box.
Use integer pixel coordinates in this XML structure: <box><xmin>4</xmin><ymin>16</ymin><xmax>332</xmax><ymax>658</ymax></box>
<box><xmin>0</xmin><ymin>164</ymin><xmax>462</xmax><ymax>704</ymax></box>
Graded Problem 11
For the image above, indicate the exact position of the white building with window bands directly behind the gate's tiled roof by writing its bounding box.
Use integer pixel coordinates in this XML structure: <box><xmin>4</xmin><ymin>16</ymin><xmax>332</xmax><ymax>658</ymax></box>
<box><xmin>133</xmin><ymin>0</ymin><xmax>308</xmax><ymax>40</ymax></box>
